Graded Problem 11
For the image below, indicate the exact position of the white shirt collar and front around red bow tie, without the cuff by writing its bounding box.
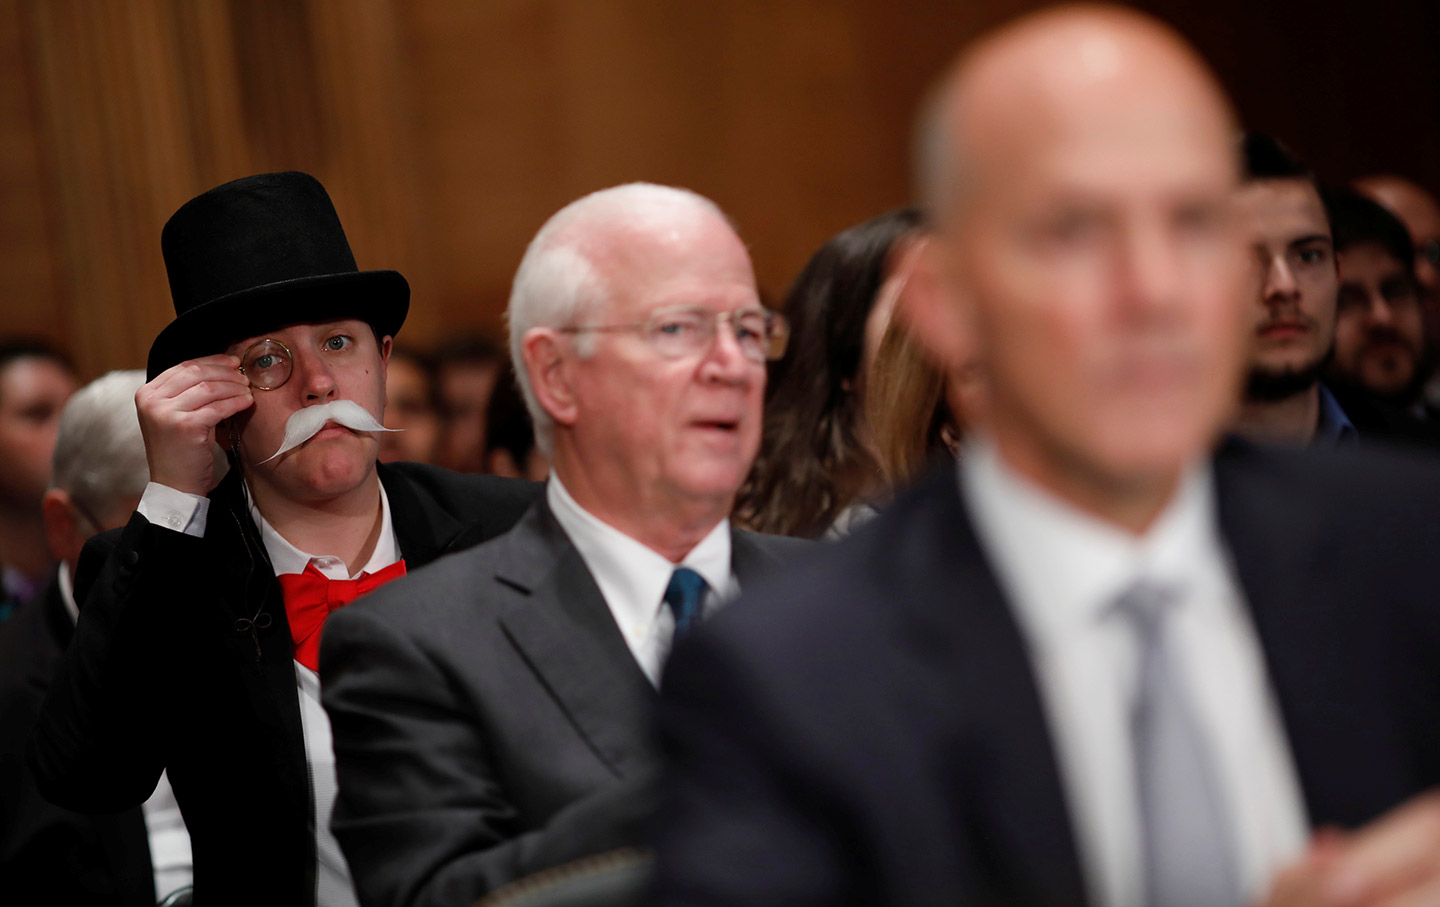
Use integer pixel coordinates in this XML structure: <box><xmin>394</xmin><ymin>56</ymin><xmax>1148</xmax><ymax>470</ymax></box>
<box><xmin>246</xmin><ymin>482</ymin><xmax>400</xmax><ymax>907</ymax></box>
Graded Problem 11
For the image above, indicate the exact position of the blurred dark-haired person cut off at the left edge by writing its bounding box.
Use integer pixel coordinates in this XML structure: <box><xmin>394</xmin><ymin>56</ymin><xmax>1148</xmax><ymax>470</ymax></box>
<box><xmin>0</xmin><ymin>341</ymin><xmax>75</xmax><ymax>621</ymax></box>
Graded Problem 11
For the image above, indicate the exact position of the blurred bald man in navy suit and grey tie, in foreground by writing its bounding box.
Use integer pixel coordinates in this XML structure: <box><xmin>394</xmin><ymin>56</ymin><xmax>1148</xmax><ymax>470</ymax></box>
<box><xmin>658</xmin><ymin>6</ymin><xmax>1440</xmax><ymax>907</ymax></box>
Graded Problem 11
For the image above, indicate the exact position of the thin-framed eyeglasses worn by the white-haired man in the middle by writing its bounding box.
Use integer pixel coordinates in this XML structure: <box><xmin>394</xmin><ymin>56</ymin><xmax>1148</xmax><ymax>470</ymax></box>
<box><xmin>560</xmin><ymin>307</ymin><xmax>791</xmax><ymax>363</ymax></box>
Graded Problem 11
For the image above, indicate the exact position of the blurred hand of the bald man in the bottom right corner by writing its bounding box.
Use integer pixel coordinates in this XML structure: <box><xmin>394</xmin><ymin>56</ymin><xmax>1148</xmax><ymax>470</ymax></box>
<box><xmin>1264</xmin><ymin>792</ymin><xmax>1440</xmax><ymax>907</ymax></box>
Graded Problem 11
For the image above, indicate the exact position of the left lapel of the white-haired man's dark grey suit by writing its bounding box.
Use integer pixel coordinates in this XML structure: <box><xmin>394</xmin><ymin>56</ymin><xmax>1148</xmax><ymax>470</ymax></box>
<box><xmin>495</xmin><ymin>497</ymin><xmax>655</xmax><ymax>776</ymax></box>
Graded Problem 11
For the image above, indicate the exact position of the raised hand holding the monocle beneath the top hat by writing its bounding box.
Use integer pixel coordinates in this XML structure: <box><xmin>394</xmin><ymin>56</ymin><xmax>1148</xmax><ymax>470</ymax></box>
<box><xmin>135</xmin><ymin>354</ymin><xmax>255</xmax><ymax>494</ymax></box>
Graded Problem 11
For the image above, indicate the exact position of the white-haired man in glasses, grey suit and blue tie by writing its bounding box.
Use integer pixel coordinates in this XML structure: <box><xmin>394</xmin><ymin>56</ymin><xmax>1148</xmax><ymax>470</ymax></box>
<box><xmin>321</xmin><ymin>184</ymin><xmax>792</xmax><ymax>906</ymax></box>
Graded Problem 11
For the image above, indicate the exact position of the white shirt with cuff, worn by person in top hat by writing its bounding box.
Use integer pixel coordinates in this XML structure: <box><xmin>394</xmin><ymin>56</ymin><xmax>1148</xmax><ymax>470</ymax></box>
<box><xmin>138</xmin><ymin>482</ymin><xmax>400</xmax><ymax>907</ymax></box>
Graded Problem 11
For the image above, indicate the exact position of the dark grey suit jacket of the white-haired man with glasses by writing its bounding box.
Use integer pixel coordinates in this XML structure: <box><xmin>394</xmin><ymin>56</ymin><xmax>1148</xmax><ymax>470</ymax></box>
<box><xmin>320</xmin><ymin>500</ymin><xmax>806</xmax><ymax>907</ymax></box>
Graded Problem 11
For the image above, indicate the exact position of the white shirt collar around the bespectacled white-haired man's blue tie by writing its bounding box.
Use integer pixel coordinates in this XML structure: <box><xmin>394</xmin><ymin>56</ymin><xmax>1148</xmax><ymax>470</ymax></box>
<box><xmin>546</xmin><ymin>472</ymin><xmax>736</xmax><ymax>626</ymax></box>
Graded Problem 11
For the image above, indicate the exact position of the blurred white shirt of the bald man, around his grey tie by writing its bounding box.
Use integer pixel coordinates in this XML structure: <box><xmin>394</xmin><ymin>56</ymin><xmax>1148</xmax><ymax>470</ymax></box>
<box><xmin>959</xmin><ymin>439</ymin><xmax>1308</xmax><ymax>907</ymax></box>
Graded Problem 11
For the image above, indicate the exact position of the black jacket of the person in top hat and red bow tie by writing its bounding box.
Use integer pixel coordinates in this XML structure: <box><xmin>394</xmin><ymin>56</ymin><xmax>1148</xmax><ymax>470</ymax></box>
<box><xmin>30</xmin><ymin>464</ymin><xmax>539</xmax><ymax>907</ymax></box>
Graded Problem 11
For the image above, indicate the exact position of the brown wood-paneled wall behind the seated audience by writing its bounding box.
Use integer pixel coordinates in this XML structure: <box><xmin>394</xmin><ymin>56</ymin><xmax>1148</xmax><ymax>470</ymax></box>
<box><xmin>0</xmin><ymin>0</ymin><xmax>1440</xmax><ymax>374</ymax></box>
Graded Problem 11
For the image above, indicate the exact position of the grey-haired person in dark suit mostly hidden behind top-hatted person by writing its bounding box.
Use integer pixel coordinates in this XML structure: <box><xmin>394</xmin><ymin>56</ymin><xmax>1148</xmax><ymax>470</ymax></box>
<box><xmin>0</xmin><ymin>370</ymin><xmax>192</xmax><ymax>907</ymax></box>
